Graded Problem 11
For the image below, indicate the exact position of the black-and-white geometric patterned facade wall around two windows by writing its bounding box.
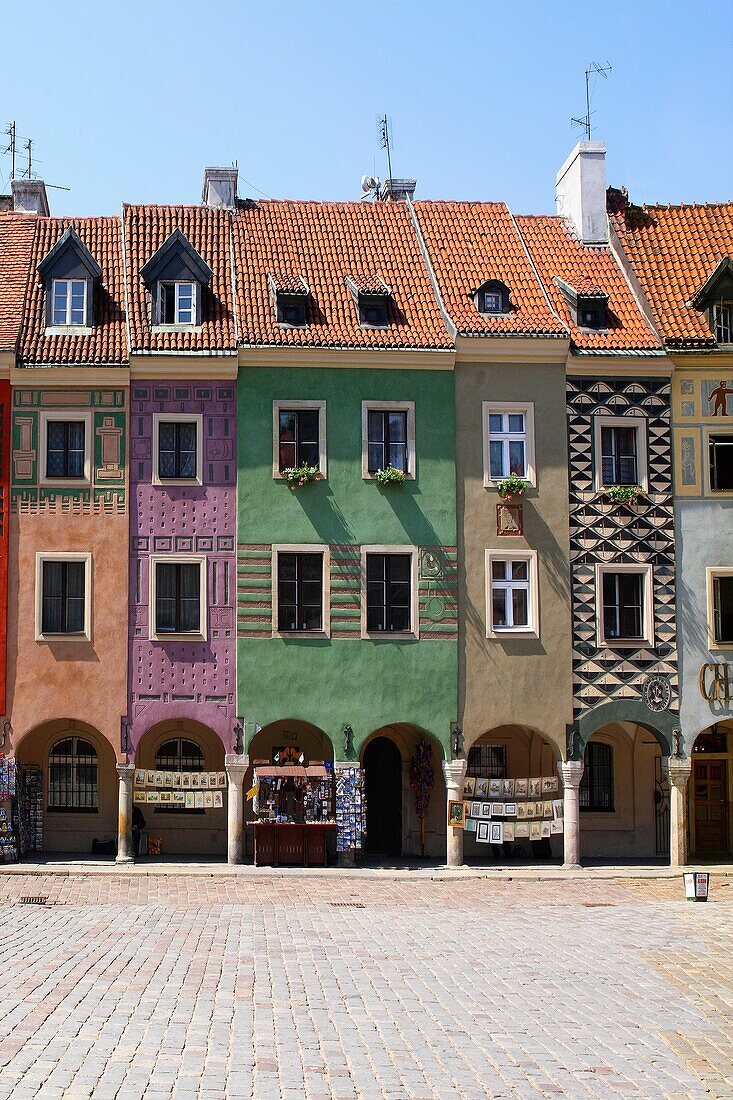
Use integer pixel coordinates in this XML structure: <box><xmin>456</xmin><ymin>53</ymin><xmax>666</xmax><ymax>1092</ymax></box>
<box><xmin>567</xmin><ymin>377</ymin><xmax>678</xmax><ymax>719</ymax></box>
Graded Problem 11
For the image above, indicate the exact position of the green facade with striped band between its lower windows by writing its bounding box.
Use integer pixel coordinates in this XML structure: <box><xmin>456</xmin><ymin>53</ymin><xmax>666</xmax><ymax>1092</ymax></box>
<box><xmin>238</xmin><ymin>367</ymin><xmax>458</xmax><ymax>759</ymax></box>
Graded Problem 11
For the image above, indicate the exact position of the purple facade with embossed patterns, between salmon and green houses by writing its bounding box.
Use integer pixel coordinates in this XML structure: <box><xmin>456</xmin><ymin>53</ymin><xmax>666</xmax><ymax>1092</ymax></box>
<box><xmin>128</xmin><ymin>382</ymin><xmax>237</xmax><ymax>751</ymax></box>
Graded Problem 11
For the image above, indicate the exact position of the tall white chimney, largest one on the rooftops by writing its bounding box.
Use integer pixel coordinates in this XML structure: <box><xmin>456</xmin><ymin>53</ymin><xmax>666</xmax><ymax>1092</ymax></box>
<box><xmin>555</xmin><ymin>141</ymin><xmax>609</xmax><ymax>244</ymax></box>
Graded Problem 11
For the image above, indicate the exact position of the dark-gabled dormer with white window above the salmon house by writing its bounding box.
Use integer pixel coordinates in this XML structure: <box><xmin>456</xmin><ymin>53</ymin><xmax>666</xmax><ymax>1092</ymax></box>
<box><xmin>37</xmin><ymin>227</ymin><xmax>102</xmax><ymax>336</ymax></box>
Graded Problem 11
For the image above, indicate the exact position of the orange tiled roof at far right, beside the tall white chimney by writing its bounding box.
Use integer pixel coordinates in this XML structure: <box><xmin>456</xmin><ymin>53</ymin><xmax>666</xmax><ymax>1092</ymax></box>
<box><xmin>611</xmin><ymin>200</ymin><xmax>733</xmax><ymax>348</ymax></box>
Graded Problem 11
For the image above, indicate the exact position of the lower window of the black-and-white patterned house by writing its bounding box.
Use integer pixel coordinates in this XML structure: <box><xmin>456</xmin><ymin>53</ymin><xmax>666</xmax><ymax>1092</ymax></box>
<box><xmin>598</xmin><ymin>565</ymin><xmax>654</xmax><ymax>646</ymax></box>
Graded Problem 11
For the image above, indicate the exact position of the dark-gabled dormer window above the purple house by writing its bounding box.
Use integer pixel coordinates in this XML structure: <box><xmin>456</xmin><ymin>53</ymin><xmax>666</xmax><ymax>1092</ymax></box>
<box><xmin>140</xmin><ymin>229</ymin><xmax>214</xmax><ymax>328</ymax></box>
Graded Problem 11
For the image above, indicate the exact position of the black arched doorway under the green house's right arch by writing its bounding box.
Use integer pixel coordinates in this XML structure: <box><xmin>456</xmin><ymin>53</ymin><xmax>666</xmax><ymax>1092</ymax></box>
<box><xmin>363</xmin><ymin>737</ymin><xmax>402</xmax><ymax>856</ymax></box>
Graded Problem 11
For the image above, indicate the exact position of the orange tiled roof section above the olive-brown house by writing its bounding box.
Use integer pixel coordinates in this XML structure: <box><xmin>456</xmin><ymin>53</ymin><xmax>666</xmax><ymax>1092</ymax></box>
<box><xmin>415</xmin><ymin>201</ymin><xmax>559</xmax><ymax>337</ymax></box>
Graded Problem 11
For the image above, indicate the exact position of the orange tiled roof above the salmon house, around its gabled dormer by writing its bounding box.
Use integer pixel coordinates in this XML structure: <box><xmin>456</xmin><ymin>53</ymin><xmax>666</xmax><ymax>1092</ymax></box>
<box><xmin>18</xmin><ymin>216</ymin><xmax>128</xmax><ymax>366</ymax></box>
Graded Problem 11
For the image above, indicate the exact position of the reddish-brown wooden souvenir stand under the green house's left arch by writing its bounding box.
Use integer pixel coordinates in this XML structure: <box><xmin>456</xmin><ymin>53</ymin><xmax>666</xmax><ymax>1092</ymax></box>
<box><xmin>250</xmin><ymin>763</ymin><xmax>336</xmax><ymax>867</ymax></box>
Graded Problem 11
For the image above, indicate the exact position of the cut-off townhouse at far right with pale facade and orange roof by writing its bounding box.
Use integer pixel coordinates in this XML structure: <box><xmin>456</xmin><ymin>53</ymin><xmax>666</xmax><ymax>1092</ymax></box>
<box><xmin>609</xmin><ymin>190</ymin><xmax>733</xmax><ymax>862</ymax></box>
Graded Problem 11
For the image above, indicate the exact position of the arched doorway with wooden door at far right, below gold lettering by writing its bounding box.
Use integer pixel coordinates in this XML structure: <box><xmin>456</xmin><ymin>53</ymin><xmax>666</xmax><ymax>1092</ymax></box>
<box><xmin>690</xmin><ymin>719</ymin><xmax>733</xmax><ymax>858</ymax></box>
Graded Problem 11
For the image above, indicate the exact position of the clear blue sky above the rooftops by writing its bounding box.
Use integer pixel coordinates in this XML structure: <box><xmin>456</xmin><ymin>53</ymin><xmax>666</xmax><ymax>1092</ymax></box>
<box><xmin>0</xmin><ymin>0</ymin><xmax>733</xmax><ymax>215</ymax></box>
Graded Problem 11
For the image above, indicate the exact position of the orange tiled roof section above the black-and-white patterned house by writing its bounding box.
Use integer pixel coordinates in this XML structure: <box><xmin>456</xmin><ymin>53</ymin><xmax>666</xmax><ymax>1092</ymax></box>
<box><xmin>516</xmin><ymin>215</ymin><xmax>661</xmax><ymax>352</ymax></box>
